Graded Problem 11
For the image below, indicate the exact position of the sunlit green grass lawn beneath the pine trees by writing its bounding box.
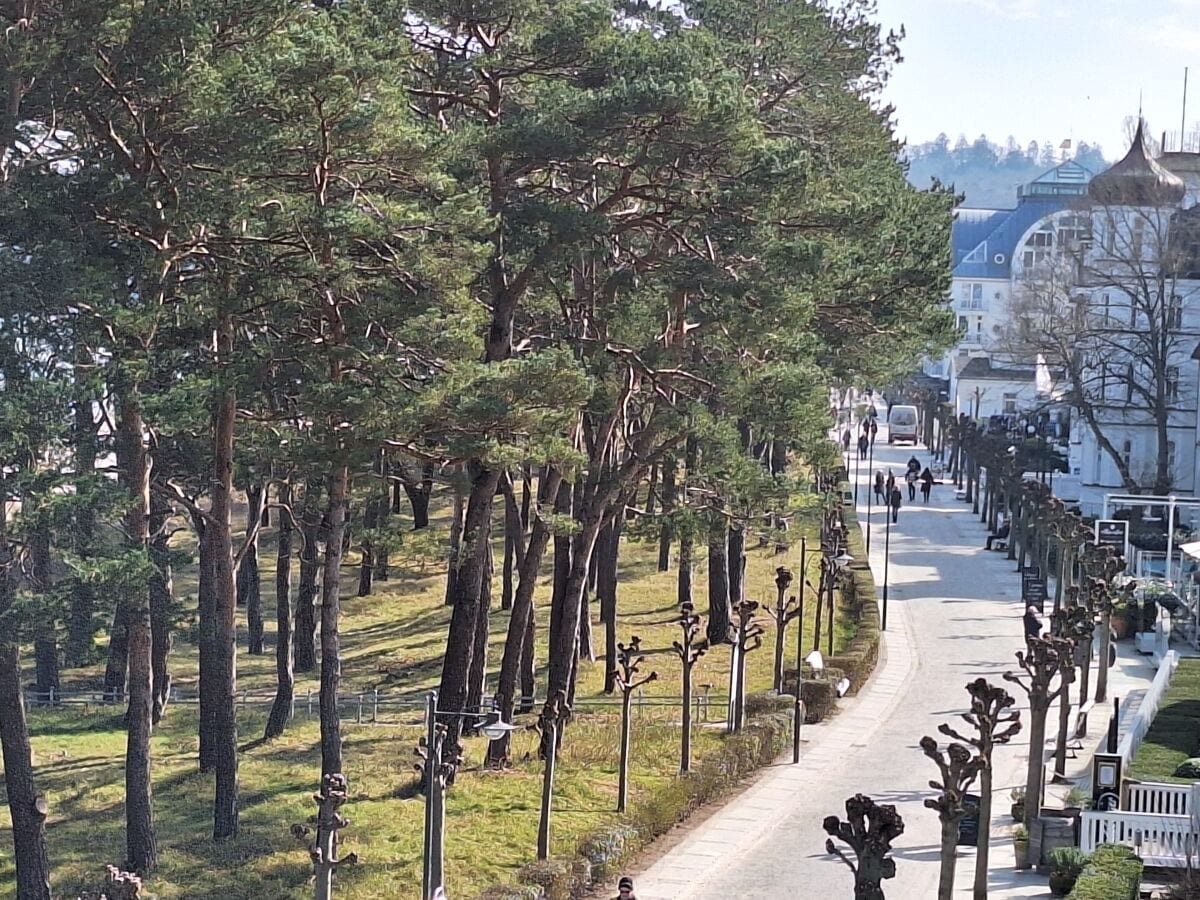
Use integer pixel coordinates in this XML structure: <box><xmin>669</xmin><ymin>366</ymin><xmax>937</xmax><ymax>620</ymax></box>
<box><xmin>0</xmin><ymin>496</ymin><xmax>854</xmax><ymax>900</ymax></box>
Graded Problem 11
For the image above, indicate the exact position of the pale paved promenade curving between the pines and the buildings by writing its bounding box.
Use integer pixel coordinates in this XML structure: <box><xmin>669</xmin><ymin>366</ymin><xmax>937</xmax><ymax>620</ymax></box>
<box><xmin>636</xmin><ymin>424</ymin><xmax>1045</xmax><ymax>900</ymax></box>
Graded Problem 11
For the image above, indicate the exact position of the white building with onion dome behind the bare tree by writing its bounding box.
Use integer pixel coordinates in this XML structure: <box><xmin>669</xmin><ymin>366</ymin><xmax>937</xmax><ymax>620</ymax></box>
<box><xmin>1069</xmin><ymin>128</ymin><xmax>1200</xmax><ymax>514</ymax></box>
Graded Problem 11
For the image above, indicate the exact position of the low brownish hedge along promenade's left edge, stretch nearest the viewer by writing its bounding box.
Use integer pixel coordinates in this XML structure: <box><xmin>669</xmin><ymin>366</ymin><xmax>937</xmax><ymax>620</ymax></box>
<box><xmin>479</xmin><ymin>710</ymin><xmax>792</xmax><ymax>900</ymax></box>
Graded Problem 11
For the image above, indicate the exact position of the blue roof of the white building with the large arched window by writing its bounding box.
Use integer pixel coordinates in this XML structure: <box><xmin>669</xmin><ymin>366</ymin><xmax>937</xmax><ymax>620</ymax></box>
<box><xmin>952</xmin><ymin>161</ymin><xmax>1091</xmax><ymax>280</ymax></box>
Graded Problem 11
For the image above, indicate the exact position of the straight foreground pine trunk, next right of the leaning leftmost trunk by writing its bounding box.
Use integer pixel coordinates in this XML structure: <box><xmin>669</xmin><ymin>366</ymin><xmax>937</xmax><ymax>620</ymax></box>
<box><xmin>116</xmin><ymin>385</ymin><xmax>158</xmax><ymax>875</ymax></box>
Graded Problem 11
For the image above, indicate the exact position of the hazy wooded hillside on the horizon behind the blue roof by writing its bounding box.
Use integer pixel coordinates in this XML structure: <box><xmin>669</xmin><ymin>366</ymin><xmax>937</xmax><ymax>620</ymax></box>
<box><xmin>905</xmin><ymin>133</ymin><xmax>1111</xmax><ymax>209</ymax></box>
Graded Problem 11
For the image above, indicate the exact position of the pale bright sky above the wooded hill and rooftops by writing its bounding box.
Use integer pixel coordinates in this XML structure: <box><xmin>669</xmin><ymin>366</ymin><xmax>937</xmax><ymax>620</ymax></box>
<box><xmin>878</xmin><ymin>0</ymin><xmax>1200</xmax><ymax>160</ymax></box>
